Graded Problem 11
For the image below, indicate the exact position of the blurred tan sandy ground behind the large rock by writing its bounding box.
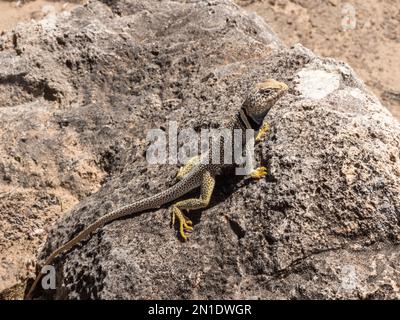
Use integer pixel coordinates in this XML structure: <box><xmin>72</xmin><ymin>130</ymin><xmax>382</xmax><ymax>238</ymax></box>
<box><xmin>0</xmin><ymin>0</ymin><xmax>400</xmax><ymax>119</ymax></box>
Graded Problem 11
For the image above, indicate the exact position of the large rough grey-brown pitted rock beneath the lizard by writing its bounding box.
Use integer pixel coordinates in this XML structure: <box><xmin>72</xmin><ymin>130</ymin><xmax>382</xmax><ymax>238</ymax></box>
<box><xmin>0</xmin><ymin>0</ymin><xmax>400</xmax><ymax>299</ymax></box>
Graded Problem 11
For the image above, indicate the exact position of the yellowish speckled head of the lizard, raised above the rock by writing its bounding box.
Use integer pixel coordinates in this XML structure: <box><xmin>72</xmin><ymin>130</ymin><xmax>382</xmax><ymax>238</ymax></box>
<box><xmin>242</xmin><ymin>79</ymin><xmax>289</xmax><ymax>125</ymax></box>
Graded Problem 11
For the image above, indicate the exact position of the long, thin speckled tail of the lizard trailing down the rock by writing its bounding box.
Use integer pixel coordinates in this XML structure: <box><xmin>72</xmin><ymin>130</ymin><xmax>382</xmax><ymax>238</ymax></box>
<box><xmin>25</xmin><ymin>180</ymin><xmax>194</xmax><ymax>300</ymax></box>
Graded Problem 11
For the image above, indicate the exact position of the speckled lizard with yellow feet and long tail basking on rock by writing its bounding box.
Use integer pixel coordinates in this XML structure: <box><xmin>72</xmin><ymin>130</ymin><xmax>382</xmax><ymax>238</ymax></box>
<box><xmin>26</xmin><ymin>79</ymin><xmax>288</xmax><ymax>299</ymax></box>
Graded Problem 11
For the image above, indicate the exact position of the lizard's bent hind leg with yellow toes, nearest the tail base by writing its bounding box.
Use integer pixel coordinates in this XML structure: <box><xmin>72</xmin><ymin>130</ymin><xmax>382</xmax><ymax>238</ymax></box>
<box><xmin>172</xmin><ymin>171</ymin><xmax>215</xmax><ymax>241</ymax></box>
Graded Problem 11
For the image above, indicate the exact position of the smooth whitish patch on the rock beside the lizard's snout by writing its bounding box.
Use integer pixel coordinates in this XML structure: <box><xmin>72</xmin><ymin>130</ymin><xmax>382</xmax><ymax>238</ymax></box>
<box><xmin>296</xmin><ymin>70</ymin><xmax>340</xmax><ymax>100</ymax></box>
